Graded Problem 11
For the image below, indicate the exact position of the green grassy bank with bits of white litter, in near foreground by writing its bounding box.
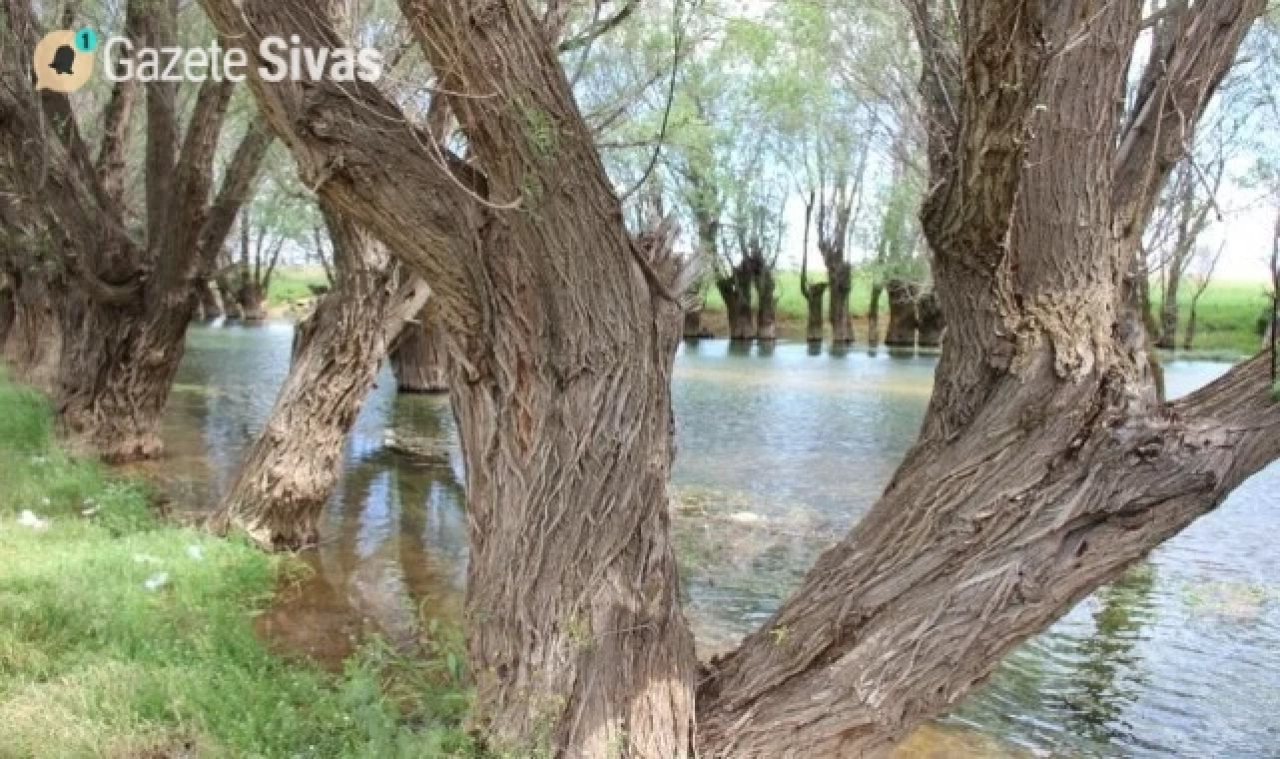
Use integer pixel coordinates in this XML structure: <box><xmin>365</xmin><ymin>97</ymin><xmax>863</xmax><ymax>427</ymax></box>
<box><xmin>0</xmin><ymin>375</ymin><xmax>475</xmax><ymax>759</ymax></box>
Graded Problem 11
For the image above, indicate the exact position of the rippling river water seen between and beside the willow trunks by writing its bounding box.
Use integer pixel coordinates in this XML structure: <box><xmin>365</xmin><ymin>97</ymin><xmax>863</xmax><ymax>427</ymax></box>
<box><xmin>147</xmin><ymin>324</ymin><xmax>1280</xmax><ymax>758</ymax></box>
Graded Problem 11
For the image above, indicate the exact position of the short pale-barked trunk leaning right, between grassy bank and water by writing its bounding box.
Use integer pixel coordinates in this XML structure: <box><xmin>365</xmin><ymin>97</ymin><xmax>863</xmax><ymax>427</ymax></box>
<box><xmin>212</xmin><ymin>207</ymin><xmax>429</xmax><ymax>549</ymax></box>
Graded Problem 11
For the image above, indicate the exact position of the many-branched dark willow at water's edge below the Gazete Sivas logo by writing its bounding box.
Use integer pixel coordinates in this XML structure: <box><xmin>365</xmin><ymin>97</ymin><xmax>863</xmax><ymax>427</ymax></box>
<box><xmin>0</xmin><ymin>0</ymin><xmax>271</xmax><ymax>462</ymax></box>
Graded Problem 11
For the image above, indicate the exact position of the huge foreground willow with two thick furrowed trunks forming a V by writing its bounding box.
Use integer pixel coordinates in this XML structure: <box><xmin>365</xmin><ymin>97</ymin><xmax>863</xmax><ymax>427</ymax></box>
<box><xmin>201</xmin><ymin>0</ymin><xmax>1280</xmax><ymax>759</ymax></box>
